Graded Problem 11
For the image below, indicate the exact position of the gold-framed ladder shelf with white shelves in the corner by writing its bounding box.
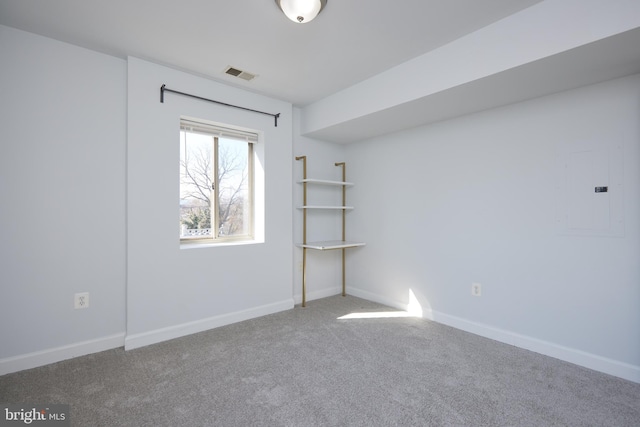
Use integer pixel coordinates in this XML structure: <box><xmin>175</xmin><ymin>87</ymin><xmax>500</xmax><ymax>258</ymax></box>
<box><xmin>296</xmin><ymin>156</ymin><xmax>365</xmax><ymax>307</ymax></box>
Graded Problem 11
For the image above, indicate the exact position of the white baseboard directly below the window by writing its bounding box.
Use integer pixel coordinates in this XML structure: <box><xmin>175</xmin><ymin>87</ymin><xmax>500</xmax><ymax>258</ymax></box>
<box><xmin>124</xmin><ymin>299</ymin><xmax>294</xmax><ymax>350</ymax></box>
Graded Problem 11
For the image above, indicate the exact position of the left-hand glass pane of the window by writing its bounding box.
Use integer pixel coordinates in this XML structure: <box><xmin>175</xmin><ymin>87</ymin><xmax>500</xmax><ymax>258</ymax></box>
<box><xmin>180</xmin><ymin>130</ymin><xmax>213</xmax><ymax>239</ymax></box>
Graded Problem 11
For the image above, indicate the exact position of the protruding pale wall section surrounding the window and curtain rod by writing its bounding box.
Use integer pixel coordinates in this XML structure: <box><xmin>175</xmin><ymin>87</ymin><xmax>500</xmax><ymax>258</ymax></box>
<box><xmin>125</xmin><ymin>58</ymin><xmax>293</xmax><ymax>348</ymax></box>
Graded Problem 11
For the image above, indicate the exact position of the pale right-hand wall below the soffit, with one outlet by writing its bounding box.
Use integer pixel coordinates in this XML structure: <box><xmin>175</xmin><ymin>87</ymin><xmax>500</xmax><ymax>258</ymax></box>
<box><xmin>346</xmin><ymin>75</ymin><xmax>640</xmax><ymax>381</ymax></box>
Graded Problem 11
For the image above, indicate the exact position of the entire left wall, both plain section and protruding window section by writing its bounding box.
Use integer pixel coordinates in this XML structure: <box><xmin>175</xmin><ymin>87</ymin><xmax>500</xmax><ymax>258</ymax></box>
<box><xmin>0</xmin><ymin>26</ymin><xmax>293</xmax><ymax>374</ymax></box>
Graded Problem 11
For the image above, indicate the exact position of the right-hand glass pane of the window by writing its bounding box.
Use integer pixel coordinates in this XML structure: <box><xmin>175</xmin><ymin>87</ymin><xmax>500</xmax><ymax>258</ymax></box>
<box><xmin>218</xmin><ymin>137</ymin><xmax>251</xmax><ymax>237</ymax></box>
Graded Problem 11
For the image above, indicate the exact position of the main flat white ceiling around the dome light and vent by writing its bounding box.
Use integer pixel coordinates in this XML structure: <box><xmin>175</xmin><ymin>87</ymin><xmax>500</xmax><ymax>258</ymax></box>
<box><xmin>0</xmin><ymin>0</ymin><xmax>540</xmax><ymax>107</ymax></box>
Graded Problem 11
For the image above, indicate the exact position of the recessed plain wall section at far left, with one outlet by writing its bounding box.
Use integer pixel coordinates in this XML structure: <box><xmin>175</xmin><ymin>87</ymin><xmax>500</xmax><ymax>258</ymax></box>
<box><xmin>0</xmin><ymin>26</ymin><xmax>126</xmax><ymax>374</ymax></box>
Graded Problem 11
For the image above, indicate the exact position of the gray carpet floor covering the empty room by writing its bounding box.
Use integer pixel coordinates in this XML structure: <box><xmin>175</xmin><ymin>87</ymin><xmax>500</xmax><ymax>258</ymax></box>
<box><xmin>0</xmin><ymin>296</ymin><xmax>640</xmax><ymax>427</ymax></box>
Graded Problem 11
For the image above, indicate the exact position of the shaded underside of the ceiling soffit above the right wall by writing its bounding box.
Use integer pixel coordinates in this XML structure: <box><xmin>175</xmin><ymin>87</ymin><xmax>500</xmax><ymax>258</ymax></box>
<box><xmin>305</xmin><ymin>27</ymin><xmax>640</xmax><ymax>144</ymax></box>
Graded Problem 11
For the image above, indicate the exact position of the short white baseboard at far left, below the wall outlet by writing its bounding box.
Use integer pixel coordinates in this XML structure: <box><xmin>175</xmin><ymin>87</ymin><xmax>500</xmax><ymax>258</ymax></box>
<box><xmin>0</xmin><ymin>333</ymin><xmax>125</xmax><ymax>375</ymax></box>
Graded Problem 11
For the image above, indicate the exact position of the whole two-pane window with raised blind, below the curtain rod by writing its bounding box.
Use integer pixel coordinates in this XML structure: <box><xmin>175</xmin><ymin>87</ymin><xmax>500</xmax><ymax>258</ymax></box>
<box><xmin>180</xmin><ymin>119</ymin><xmax>258</xmax><ymax>243</ymax></box>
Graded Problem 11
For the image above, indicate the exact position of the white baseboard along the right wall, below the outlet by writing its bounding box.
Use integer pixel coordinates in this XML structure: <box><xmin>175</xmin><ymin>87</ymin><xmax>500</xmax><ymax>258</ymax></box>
<box><xmin>349</xmin><ymin>288</ymin><xmax>640</xmax><ymax>383</ymax></box>
